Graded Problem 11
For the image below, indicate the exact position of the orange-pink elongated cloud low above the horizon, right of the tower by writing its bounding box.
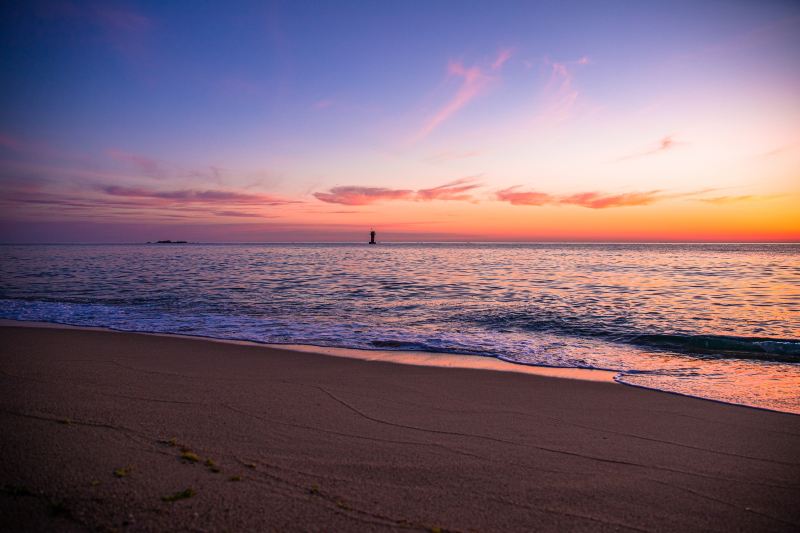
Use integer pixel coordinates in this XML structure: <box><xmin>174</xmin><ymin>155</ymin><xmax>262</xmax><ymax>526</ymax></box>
<box><xmin>495</xmin><ymin>186</ymin><xmax>708</xmax><ymax>209</ymax></box>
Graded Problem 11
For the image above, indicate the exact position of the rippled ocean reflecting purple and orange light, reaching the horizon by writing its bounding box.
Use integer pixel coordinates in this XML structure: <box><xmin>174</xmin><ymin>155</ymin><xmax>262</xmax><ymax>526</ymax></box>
<box><xmin>0</xmin><ymin>243</ymin><xmax>800</xmax><ymax>413</ymax></box>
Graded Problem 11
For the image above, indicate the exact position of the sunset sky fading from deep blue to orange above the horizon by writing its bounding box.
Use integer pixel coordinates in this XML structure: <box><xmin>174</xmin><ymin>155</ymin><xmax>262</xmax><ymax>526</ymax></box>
<box><xmin>0</xmin><ymin>0</ymin><xmax>800</xmax><ymax>243</ymax></box>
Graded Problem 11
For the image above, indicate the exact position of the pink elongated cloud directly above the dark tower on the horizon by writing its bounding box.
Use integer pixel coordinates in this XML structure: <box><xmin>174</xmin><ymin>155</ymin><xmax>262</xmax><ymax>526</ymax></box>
<box><xmin>314</xmin><ymin>178</ymin><xmax>481</xmax><ymax>205</ymax></box>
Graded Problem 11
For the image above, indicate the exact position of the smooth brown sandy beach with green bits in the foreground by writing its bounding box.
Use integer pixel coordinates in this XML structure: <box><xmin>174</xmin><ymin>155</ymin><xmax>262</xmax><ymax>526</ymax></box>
<box><xmin>0</xmin><ymin>326</ymin><xmax>800</xmax><ymax>532</ymax></box>
